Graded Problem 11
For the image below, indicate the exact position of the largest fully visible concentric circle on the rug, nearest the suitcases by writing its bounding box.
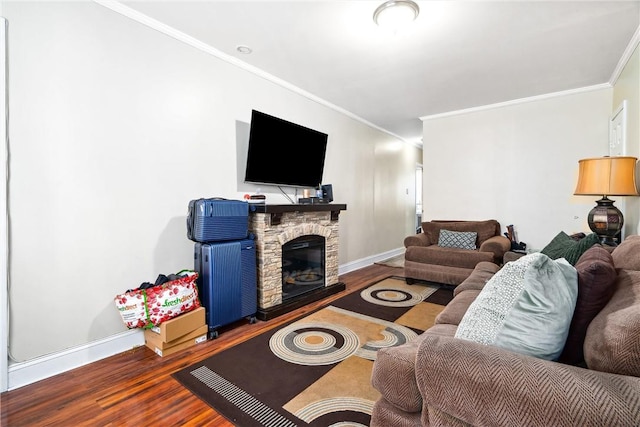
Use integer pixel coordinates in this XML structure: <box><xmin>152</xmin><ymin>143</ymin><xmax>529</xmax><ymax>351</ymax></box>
<box><xmin>269</xmin><ymin>322</ymin><xmax>360</xmax><ymax>366</ymax></box>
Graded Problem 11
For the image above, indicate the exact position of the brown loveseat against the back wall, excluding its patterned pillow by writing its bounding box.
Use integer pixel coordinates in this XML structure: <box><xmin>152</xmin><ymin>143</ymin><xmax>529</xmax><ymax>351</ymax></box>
<box><xmin>404</xmin><ymin>219</ymin><xmax>511</xmax><ymax>285</ymax></box>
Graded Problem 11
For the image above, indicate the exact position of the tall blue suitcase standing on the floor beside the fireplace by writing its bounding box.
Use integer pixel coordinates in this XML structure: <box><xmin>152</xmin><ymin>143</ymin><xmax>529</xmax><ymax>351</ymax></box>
<box><xmin>194</xmin><ymin>239</ymin><xmax>258</xmax><ymax>338</ymax></box>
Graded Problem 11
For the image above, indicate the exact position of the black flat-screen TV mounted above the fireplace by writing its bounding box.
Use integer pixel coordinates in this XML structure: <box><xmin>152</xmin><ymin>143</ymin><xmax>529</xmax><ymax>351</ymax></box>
<box><xmin>244</xmin><ymin>110</ymin><xmax>328</xmax><ymax>188</ymax></box>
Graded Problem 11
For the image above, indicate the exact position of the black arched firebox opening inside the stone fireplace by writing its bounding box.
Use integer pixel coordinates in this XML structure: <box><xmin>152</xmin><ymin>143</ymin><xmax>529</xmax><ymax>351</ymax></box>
<box><xmin>282</xmin><ymin>235</ymin><xmax>325</xmax><ymax>302</ymax></box>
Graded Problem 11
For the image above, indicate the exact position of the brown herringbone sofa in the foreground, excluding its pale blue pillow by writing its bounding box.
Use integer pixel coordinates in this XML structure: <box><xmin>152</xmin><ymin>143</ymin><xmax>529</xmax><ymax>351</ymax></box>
<box><xmin>371</xmin><ymin>236</ymin><xmax>640</xmax><ymax>427</ymax></box>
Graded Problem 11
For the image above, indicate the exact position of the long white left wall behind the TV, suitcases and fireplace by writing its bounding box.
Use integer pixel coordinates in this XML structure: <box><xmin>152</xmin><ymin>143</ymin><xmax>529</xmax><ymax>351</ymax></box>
<box><xmin>2</xmin><ymin>1</ymin><xmax>421</xmax><ymax>384</ymax></box>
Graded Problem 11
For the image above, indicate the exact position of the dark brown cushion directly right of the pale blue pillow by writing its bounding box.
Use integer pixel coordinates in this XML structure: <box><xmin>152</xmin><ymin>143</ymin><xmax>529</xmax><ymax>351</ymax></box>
<box><xmin>559</xmin><ymin>244</ymin><xmax>617</xmax><ymax>365</ymax></box>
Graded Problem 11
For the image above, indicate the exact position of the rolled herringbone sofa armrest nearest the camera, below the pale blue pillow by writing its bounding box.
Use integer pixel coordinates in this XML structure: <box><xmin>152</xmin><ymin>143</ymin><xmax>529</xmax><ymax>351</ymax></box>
<box><xmin>416</xmin><ymin>336</ymin><xmax>640</xmax><ymax>426</ymax></box>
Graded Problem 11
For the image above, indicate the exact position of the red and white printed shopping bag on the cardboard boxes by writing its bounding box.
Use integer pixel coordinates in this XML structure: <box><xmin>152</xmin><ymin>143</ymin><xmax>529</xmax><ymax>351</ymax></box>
<box><xmin>114</xmin><ymin>272</ymin><xmax>200</xmax><ymax>329</ymax></box>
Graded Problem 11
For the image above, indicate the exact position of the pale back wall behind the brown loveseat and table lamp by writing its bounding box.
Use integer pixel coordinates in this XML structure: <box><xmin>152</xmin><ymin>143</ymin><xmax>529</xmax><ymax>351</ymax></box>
<box><xmin>423</xmin><ymin>88</ymin><xmax>613</xmax><ymax>249</ymax></box>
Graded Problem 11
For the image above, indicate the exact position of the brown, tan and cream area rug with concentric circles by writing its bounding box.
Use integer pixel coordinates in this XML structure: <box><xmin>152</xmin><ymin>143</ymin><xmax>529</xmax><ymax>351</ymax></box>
<box><xmin>173</xmin><ymin>277</ymin><xmax>452</xmax><ymax>427</ymax></box>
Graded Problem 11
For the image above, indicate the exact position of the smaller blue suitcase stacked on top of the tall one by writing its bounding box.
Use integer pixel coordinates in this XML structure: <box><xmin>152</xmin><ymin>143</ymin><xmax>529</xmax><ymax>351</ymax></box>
<box><xmin>187</xmin><ymin>198</ymin><xmax>249</xmax><ymax>243</ymax></box>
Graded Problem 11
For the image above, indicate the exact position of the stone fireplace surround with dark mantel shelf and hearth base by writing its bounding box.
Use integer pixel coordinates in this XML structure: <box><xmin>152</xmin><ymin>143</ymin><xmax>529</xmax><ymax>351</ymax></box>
<box><xmin>249</xmin><ymin>203</ymin><xmax>347</xmax><ymax>320</ymax></box>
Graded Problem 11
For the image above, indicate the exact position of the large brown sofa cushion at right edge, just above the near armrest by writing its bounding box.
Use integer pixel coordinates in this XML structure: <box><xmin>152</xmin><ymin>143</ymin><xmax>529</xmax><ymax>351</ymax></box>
<box><xmin>584</xmin><ymin>270</ymin><xmax>640</xmax><ymax>377</ymax></box>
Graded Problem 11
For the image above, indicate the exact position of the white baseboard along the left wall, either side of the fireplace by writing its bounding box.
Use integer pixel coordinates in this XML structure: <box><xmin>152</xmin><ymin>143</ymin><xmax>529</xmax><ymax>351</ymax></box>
<box><xmin>7</xmin><ymin>252</ymin><xmax>404</xmax><ymax>391</ymax></box>
